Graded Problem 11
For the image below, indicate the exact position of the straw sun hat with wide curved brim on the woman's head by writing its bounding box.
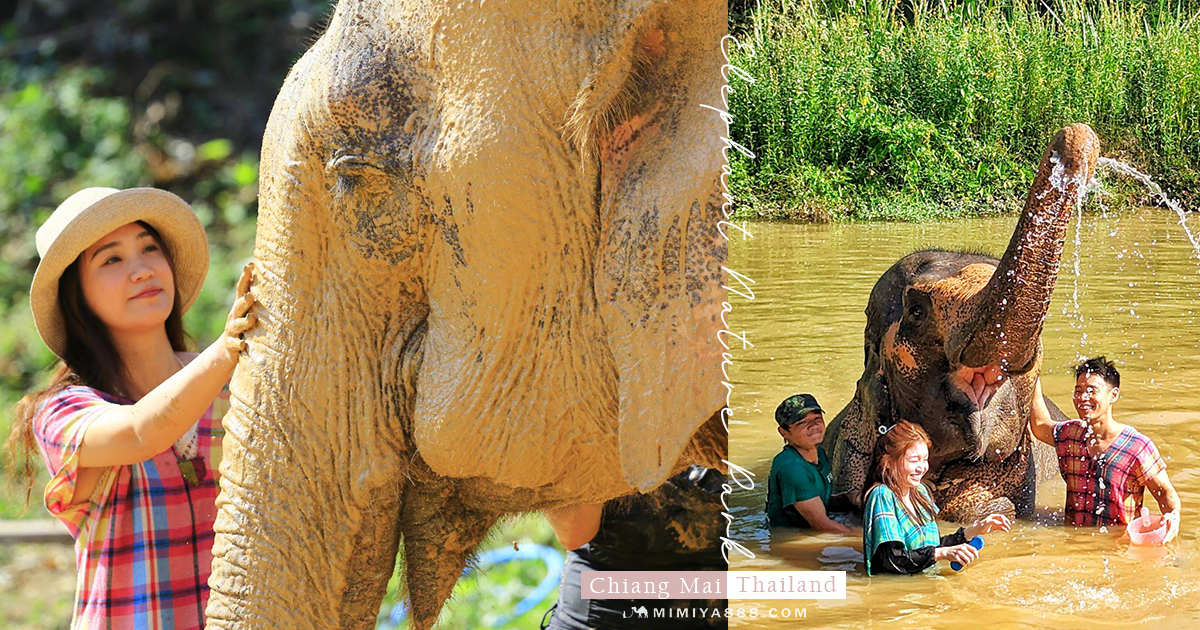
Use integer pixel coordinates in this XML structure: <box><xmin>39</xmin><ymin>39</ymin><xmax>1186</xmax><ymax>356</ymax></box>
<box><xmin>29</xmin><ymin>188</ymin><xmax>209</xmax><ymax>359</ymax></box>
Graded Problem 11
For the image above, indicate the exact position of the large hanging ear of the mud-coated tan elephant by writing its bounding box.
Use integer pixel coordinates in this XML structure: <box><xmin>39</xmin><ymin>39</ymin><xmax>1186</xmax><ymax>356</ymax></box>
<box><xmin>585</xmin><ymin>0</ymin><xmax>724</xmax><ymax>492</ymax></box>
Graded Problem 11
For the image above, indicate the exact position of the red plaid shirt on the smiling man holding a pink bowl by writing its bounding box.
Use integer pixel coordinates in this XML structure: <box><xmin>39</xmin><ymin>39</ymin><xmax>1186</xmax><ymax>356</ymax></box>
<box><xmin>1054</xmin><ymin>420</ymin><xmax>1166</xmax><ymax>526</ymax></box>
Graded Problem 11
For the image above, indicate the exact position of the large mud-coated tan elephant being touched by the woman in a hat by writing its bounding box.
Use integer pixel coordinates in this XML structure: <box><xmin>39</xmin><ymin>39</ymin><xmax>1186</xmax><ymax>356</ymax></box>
<box><xmin>208</xmin><ymin>0</ymin><xmax>727</xmax><ymax>630</ymax></box>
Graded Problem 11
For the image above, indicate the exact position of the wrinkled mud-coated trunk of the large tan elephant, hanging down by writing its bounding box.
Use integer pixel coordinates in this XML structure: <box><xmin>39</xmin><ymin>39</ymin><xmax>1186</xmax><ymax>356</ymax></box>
<box><xmin>206</xmin><ymin>27</ymin><xmax>427</xmax><ymax>630</ymax></box>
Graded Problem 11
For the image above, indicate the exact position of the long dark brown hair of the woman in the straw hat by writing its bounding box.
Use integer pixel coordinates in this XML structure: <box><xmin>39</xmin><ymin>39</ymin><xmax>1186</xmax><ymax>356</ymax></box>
<box><xmin>5</xmin><ymin>221</ymin><xmax>191</xmax><ymax>508</ymax></box>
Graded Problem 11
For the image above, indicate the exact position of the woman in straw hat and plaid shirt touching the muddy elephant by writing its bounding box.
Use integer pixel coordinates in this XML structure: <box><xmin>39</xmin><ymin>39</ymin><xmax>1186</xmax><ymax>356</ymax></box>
<box><xmin>10</xmin><ymin>188</ymin><xmax>254</xmax><ymax>630</ymax></box>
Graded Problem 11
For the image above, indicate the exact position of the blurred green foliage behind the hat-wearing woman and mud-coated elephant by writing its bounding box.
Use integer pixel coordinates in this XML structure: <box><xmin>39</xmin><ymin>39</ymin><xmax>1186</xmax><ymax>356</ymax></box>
<box><xmin>0</xmin><ymin>0</ymin><xmax>557</xmax><ymax>630</ymax></box>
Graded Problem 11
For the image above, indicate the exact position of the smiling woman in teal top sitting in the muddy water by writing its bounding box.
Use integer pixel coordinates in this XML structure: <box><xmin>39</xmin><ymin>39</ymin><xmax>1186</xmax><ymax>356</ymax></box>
<box><xmin>863</xmin><ymin>421</ymin><xmax>1012</xmax><ymax>575</ymax></box>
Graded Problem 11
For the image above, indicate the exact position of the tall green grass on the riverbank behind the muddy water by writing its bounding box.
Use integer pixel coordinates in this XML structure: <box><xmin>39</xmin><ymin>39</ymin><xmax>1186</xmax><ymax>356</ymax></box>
<box><xmin>730</xmin><ymin>0</ymin><xmax>1200</xmax><ymax>221</ymax></box>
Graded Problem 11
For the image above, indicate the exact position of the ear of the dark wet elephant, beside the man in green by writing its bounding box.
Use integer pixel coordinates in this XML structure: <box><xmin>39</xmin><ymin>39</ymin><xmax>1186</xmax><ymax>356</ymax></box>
<box><xmin>824</xmin><ymin>336</ymin><xmax>894</xmax><ymax>505</ymax></box>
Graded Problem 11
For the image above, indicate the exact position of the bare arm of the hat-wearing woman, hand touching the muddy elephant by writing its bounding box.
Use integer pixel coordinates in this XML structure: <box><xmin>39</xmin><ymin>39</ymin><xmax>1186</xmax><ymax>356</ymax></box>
<box><xmin>79</xmin><ymin>263</ymin><xmax>256</xmax><ymax>468</ymax></box>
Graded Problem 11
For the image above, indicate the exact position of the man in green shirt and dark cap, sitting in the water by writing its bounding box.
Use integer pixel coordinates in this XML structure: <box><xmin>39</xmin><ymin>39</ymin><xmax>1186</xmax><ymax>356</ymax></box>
<box><xmin>767</xmin><ymin>394</ymin><xmax>856</xmax><ymax>534</ymax></box>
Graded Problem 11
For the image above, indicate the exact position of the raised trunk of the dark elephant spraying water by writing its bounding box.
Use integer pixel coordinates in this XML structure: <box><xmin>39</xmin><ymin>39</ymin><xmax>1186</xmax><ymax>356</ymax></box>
<box><xmin>952</xmin><ymin>122</ymin><xmax>1100</xmax><ymax>373</ymax></box>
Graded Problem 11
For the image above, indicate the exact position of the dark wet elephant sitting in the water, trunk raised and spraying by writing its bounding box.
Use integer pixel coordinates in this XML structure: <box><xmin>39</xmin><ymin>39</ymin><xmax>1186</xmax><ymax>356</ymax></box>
<box><xmin>824</xmin><ymin>124</ymin><xmax>1100</xmax><ymax>522</ymax></box>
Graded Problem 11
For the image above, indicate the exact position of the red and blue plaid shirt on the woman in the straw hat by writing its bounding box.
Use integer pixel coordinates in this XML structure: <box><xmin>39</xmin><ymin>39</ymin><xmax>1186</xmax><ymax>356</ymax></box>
<box><xmin>34</xmin><ymin>386</ymin><xmax>229</xmax><ymax>630</ymax></box>
